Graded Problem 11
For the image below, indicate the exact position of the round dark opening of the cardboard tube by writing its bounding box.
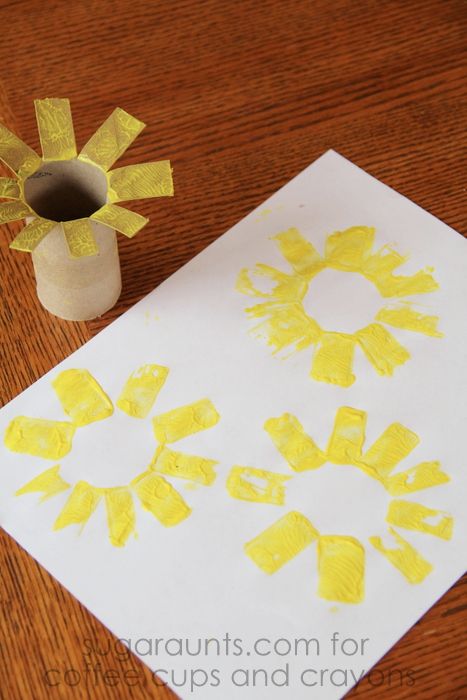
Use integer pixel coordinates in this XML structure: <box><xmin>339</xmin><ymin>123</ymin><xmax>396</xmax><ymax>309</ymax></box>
<box><xmin>24</xmin><ymin>158</ymin><xmax>107</xmax><ymax>221</ymax></box>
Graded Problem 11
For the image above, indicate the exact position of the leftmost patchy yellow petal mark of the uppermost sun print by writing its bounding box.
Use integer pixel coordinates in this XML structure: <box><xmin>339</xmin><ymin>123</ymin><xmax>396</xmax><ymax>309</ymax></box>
<box><xmin>236</xmin><ymin>263</ymin><xmax>308</xmax><ymax>302</ymax></box>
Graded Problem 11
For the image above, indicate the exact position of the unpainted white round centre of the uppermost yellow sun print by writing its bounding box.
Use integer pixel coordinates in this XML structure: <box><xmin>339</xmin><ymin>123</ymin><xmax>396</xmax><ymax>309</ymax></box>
<box><xmin>303</xmin><ymin>268</ymin><xmax>384</xmax><ymax>333</ymax></box>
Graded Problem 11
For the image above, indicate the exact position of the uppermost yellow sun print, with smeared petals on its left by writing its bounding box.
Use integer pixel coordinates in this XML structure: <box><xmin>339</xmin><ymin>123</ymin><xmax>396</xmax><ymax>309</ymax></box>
<box><xmin>236</xmin><ymin>226</ymin><xmax>442</xmax><ymax>387</ymax></box>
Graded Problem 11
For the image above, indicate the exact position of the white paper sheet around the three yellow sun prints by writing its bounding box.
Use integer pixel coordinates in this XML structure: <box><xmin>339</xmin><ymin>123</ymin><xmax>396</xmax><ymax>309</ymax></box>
<box><xmin>0</xmin><ymin>151</ymin><xmax>467</xmax><ymax>700</ymax></box>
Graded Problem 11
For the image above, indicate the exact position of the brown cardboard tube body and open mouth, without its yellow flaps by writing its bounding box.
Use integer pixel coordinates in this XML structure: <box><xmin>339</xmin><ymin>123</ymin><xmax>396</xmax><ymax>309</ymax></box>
<box><xmin>25</xmin><ymin>159</ymin><xmax>122</xmax><ymax>321</ymax></box>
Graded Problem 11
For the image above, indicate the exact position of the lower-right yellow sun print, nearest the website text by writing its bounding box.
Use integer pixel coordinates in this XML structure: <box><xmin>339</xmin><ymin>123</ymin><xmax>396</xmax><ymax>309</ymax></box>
<box><xmin>226</xmin><ymin>406</ymin><xmax>453</xmax><ymax>603</ymax></box>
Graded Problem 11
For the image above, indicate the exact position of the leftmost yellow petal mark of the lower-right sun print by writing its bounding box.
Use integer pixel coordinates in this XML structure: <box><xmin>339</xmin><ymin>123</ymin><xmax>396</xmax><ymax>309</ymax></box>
<box><xmin>227</xmin><ymin>467</ymin><xmax>291</xmax><ymax>506</ymax></box>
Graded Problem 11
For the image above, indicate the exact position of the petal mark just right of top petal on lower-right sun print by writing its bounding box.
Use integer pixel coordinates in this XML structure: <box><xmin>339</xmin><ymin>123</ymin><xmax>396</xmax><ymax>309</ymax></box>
<box><xmin>361</xmin><ymin>423</ymin><xmax>420</xmax><ymax>478</ymax></box>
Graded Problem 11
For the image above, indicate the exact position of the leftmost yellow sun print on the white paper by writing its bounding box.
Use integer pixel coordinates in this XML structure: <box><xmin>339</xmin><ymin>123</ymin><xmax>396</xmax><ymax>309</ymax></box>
<box><xmin>4</xmin><ymin>364</ymin><xmax>220</xmax><ymax>547</ymax></box>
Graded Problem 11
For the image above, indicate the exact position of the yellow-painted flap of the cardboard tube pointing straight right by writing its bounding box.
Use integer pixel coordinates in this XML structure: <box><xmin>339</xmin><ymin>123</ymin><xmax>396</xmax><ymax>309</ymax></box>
<box><xmin>109</xmin><ymin>160</ymin><xmax>174</xmax><ymax>202</ymax></box>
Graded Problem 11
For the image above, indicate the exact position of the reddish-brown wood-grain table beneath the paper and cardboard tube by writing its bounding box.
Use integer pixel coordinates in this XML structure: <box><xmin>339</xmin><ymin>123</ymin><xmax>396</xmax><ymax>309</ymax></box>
<box><xmin>0</xmin><ymin>0</ymin><xmax>467</xmax><ymax>700</ymax></box>
